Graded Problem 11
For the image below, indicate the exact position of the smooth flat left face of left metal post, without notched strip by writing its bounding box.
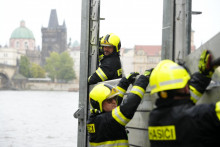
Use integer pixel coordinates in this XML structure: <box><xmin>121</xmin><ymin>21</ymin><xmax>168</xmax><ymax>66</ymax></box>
<box><xmin>74</xmin><ymin>0</ymin><xmax>90</xmax><ymax>147</ymax></box>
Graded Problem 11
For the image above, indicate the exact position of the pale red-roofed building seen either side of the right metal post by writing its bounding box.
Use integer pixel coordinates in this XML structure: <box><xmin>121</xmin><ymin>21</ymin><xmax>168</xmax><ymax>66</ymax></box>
<box><xmin>121</xmin><ymin>31</ymin><xmax>196</xmax><ymax>75</ymax></box>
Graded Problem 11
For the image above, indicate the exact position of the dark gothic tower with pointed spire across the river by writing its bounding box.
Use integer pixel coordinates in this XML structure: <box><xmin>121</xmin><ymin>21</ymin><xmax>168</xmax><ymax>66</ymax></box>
<box><xmin>41</xmin><ymin>9</ymin><xmax>67</xmax><ymax>65</ymax></box>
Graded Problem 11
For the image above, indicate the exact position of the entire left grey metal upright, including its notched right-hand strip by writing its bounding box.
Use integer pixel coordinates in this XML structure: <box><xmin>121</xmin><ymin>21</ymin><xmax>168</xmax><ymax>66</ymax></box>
<box><xmin>74</xmin><ymin>0</ymin><xmax>100</xmax><ymax>147</ymax></box>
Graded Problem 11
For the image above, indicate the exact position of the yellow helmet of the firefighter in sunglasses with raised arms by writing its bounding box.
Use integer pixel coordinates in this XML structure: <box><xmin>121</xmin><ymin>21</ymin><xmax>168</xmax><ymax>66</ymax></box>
<box><xmin>89</xmin><ymin>84</ymin><xmax>119</xmax><ymax>112</ymax></box>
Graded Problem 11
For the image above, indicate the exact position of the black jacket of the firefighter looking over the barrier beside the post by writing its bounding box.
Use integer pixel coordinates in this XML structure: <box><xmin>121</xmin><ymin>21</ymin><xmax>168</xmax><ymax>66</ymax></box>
<box><xmin>88</xmin><ymin>52</ymin><xmax>122</xmax><ymax>84</ymax></box>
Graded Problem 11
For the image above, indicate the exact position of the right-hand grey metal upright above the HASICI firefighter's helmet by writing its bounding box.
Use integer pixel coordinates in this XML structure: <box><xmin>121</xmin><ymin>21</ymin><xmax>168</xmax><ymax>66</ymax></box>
<box><xmin>161</xmin><ymin>0</ymin><xmax>192</xmax><ymax>61</ymax></box>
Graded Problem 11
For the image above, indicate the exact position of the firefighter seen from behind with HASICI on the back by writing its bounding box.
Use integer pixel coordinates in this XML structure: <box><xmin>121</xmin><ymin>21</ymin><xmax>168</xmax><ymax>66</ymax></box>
<box><xmin>148</xmin><ymin>50</ymin><xmax>220</xmax><ymax>147</ymax></box>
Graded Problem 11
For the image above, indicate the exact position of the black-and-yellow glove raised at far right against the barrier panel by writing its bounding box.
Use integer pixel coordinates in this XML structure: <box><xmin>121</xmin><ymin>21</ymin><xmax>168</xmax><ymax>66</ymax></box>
<box><xmin>199</xmin><ymin>50</ymin><xmax>216</xmax><ymax>78</ymax></box>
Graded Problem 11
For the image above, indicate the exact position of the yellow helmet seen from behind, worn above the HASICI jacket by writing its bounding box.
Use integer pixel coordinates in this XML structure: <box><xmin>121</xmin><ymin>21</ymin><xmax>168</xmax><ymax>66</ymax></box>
<box><xmin>150</xmin><ymin>60</ymin><xmax>190</xmax><ymax>94</ymax></box>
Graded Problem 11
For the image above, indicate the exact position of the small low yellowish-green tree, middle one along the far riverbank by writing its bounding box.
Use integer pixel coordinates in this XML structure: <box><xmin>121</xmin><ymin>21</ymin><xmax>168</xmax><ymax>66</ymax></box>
<box><xmin>30</xmin><ymin>63</ymin><xmax>45</xmax><ymax>78</ymax></box>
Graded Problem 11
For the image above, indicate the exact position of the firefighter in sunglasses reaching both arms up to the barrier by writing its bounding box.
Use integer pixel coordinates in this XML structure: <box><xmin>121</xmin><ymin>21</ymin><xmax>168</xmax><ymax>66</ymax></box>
<box><xmin>87</xmin><ymin>70</ymin><xmax>151</xmax><ymax>147</ymax></box>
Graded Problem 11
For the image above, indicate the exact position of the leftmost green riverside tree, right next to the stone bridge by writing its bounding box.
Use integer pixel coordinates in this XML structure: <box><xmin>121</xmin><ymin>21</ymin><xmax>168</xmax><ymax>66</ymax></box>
<box><xmin>19</xmin><ymin>56</ymin><xmax>30</xmax><ymax>78</ymax></box>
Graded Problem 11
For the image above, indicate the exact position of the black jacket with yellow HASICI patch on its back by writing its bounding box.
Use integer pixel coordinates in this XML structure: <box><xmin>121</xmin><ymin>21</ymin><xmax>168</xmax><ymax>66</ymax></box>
<box><xmin>148</xmin><ymin>73</ymin><xmax>220</xmax><ymax>147</ymax></box>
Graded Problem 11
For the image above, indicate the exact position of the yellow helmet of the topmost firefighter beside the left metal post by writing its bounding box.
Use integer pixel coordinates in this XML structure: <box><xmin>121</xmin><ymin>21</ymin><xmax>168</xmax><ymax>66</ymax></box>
<box><xmin>100</xmin><ymin>33</ymin><xmax>121</xmax><ymax>52</ymax></box>
